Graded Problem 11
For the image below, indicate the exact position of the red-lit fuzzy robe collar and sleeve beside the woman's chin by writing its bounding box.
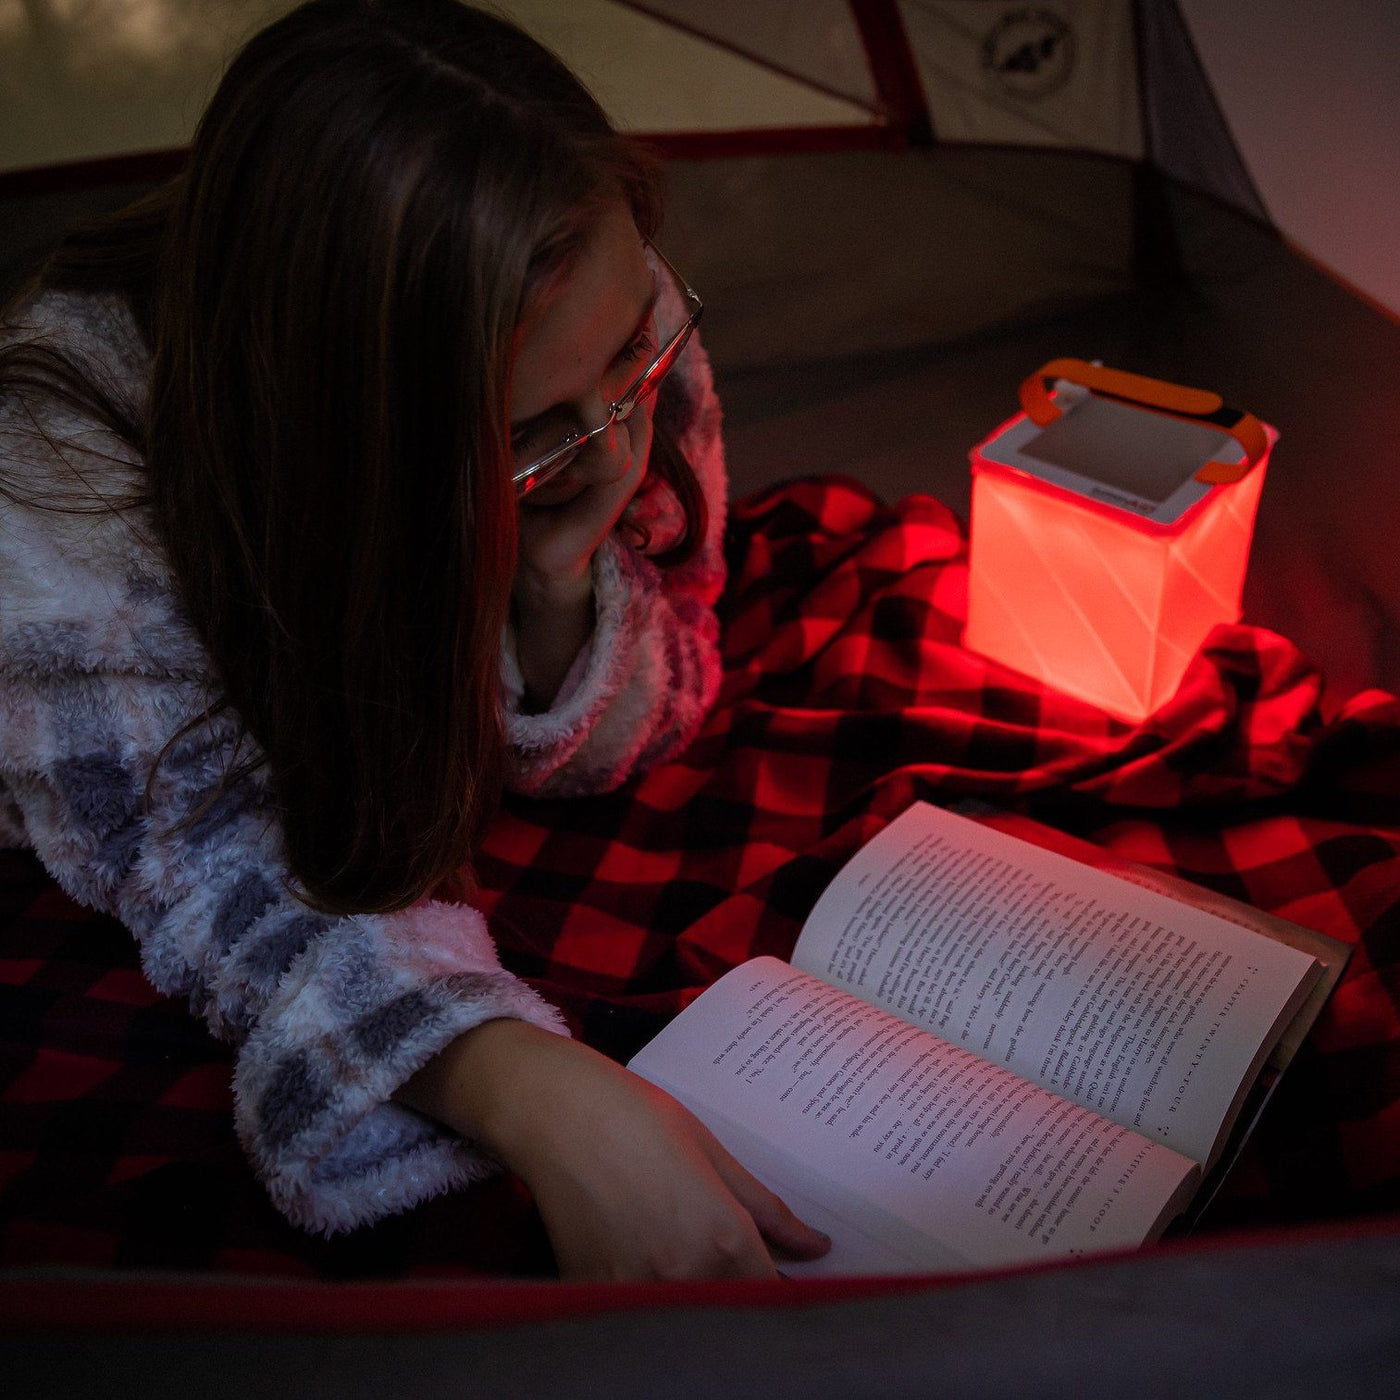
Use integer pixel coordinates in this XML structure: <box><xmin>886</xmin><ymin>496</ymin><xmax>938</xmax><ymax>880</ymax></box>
<box><xmin>503</xmin><ymin>315</ymin><xmax>727</xmax><ymax>797</ymax></box>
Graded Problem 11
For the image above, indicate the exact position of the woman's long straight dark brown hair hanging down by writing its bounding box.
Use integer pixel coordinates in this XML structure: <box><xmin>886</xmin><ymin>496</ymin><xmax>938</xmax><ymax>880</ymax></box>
<box><xmin>0</xmin><ymin>0</ymin><xmax>703</xmax><ymax>913</ymax></box>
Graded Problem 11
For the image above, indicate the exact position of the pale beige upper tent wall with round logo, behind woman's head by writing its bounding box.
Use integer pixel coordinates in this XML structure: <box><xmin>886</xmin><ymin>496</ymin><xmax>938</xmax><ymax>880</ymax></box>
<box><xmin>0</xmin><ymin>0</ymin><xmax>1238</xmax><ymax>194</ymax></box>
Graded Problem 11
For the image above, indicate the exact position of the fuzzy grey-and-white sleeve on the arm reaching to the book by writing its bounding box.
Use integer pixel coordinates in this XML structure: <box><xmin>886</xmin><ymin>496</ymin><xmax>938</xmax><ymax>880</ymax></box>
<box><xmin>0</xmin><ymin>408</ymin><xmax>567</xmax><ymax>1235</ymax></box>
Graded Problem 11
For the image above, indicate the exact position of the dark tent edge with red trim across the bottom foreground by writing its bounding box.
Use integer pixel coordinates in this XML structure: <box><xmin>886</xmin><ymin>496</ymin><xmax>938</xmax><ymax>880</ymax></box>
<box><xmin>8</xmin><ymin>1222</ymin><xmax>1400</xmax><ymax>1400</ymax></box>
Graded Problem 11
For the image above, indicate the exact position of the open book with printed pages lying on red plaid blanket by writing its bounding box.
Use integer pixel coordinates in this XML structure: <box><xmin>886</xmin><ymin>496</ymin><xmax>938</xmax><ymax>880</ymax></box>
<box><xmin>630</xmin><ymin>802</ymin><xmax>1347</xmax><ymax>1275</ymax></box>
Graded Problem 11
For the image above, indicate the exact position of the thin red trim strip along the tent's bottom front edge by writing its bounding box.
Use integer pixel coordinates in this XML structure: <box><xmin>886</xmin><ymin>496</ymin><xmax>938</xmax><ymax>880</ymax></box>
<box><xmin>0</xmin><ymin>1217</ymin><xmax>1400</xmax><ymax>1332</ymax></box>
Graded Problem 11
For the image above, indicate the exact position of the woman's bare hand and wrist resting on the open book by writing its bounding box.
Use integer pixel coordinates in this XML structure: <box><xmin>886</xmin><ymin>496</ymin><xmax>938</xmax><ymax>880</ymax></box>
<box><xmin>400</xmin><ymin>1019</ymin><xmax>830</xmax><ymax>1280</ymax></box>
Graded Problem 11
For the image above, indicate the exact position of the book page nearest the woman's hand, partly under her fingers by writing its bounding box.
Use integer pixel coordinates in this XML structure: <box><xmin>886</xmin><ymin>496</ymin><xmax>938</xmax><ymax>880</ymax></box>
<box><xmin>630</xmin><ymin>958</ymin><xmax>1200</xmax><ymax>1274</ymax></box>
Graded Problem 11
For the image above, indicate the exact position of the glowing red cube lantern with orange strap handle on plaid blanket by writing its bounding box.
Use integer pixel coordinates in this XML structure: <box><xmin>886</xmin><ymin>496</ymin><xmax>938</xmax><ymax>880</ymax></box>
<box><xmin>963</xmin><ymin>360</ymin><xmax>1278</xmax><ymax>722</ymax></box>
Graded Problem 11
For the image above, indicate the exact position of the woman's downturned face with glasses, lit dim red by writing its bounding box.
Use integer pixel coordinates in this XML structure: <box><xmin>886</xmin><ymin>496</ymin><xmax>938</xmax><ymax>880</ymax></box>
<box><xmin>510</xmin><ymin>199</ymin><xmax>657</xmax><ymax>510</ymax></box>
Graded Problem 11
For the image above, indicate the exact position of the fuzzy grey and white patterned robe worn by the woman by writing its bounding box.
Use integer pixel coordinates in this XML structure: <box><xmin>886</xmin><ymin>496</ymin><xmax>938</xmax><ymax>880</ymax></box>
<box><xmin>0</xmin><ymin>278</ymin><xmax>725</xmax><ymax>1233</ymax></box>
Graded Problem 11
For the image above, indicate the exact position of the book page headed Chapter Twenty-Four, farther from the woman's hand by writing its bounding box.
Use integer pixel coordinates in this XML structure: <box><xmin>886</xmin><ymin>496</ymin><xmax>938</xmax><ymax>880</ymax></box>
<box><xmin>792</xmin><ymin>802</ymin><xmax>1319</xmax><ymax>1165</ymax></box>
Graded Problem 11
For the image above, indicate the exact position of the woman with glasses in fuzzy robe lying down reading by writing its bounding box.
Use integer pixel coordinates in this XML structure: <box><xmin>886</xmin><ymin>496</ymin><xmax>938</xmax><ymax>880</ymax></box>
<box><xmin>0</xmin><ymin>0</ymin><xmax>826</xmax><ymax>1277</ymax></box>
